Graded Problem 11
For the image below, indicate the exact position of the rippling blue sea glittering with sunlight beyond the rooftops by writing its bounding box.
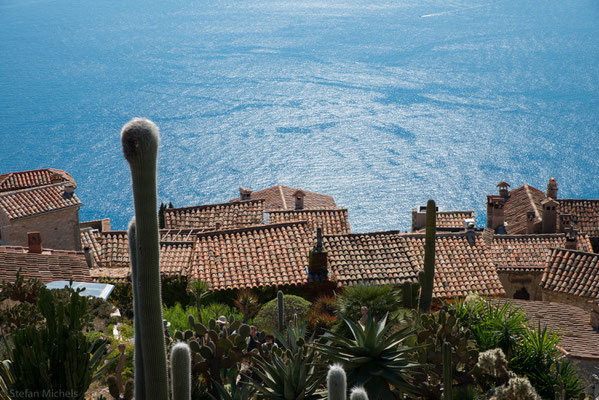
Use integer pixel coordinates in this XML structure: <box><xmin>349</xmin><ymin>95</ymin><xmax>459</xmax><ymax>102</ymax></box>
<box><xmin>0</xmin><ymin>0</ymin><xmax>599</xmax><ymax>231</ymax></box>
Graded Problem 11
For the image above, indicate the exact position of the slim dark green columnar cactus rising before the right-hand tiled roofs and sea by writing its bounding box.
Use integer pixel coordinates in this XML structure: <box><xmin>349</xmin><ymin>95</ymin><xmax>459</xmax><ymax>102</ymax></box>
<box><xmin>418</xmin><ymin>200</ymin><xmax>437</xmax><ymax>313</ymax></box>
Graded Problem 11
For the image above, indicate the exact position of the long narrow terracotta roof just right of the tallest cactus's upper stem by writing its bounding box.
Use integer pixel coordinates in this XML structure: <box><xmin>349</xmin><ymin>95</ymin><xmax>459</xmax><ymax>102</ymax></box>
<box><xmin>164</xmin><ymin>199</ymin><xmax>264</xmax><ymax>230</ymax></box>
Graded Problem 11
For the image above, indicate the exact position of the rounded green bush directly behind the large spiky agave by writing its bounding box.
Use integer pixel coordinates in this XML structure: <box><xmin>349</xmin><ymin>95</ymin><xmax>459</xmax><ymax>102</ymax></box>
<box><xmin>335</xmin><ymin>284</ymin><xmax>402</xmax><ymax>334</ymax></box>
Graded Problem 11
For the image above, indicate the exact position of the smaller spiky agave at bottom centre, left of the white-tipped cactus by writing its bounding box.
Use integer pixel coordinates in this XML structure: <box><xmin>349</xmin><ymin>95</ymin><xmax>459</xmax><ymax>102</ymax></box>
<box><xmin>251</xmin><ymin>345</ymin><xmax>326</xmax><ymax>400</ymax></box>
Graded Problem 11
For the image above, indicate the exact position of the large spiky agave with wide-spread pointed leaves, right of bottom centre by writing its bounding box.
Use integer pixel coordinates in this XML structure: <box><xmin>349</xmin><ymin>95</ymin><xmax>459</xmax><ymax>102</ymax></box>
<box><xmin>315</xmin><ymin>315</ymin><xmax>419</xmax><ymax>400</ymax></box>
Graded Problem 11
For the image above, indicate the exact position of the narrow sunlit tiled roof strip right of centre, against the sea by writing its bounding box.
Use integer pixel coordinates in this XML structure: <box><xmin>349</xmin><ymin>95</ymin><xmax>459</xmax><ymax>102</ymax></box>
<box><xmin>268</xmin><ymin>208</ymin><xmax>350</xmax><ymax>235</ymax></box>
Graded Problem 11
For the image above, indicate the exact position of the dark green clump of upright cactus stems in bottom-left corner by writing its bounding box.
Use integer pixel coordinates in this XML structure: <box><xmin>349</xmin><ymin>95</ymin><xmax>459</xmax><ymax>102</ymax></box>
<box><xmin>2</xmin><ymin>289</ymin><xmax>109</xmax><ymax>399</ymax></box>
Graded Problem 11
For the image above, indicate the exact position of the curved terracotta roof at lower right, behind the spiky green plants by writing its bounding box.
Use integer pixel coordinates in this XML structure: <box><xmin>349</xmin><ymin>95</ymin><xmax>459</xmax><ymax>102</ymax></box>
<box><xmin>491</xmin><ymin>299</ymin><xmax>599</xmax><ymax>361</ymax></box>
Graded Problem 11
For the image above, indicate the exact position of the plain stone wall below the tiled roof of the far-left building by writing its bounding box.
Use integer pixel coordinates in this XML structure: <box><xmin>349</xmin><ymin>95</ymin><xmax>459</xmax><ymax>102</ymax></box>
<box><xmin>0</xmin><ymin>207</ymin><xmax>81</xmax><ymax>250</ymax></box>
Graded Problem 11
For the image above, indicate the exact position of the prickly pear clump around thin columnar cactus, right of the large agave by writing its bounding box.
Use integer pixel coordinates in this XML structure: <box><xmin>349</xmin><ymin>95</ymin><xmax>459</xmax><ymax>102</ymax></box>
<box><xmin>416</xmin><ymin>307</ymin><xmax>478</xmax><ymax>399</ymax></box>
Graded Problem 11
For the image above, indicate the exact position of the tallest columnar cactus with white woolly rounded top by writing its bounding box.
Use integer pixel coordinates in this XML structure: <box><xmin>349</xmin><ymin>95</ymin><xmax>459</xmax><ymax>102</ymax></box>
<box><xmin>121</xmin><ymin>118</ymin><xmax>168</xmax><ymax>400</ymax></box>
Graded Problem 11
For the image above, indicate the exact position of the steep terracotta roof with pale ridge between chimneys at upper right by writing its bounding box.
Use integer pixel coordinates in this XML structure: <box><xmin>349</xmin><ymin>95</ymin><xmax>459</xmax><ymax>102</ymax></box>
<box><xmin>503</xmin><ymin>184</ymin><xmax>545</xmax><ymax>235</ymax></box>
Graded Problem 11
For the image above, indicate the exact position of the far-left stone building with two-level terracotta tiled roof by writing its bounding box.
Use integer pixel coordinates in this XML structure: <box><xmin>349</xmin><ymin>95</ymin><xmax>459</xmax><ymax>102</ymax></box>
<box><xmin>0</xmin><ymin>169</ymin><xmax>82</xmax><ymax>250</ymax></box>
